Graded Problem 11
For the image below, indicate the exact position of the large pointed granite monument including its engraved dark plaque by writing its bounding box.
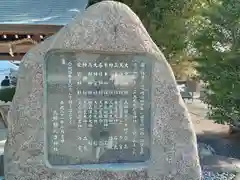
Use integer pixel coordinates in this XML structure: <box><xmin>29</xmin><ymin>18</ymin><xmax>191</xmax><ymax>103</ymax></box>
<box><xmin>5</xmin><ymin>1</ymin><xmax>201</xmax><ymax>180</ymax></box>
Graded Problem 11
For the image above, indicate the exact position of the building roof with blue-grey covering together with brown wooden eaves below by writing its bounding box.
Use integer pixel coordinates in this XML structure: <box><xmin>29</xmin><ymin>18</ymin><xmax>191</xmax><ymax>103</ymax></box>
<box><xmin>0</xmin><ymin>0</ymin><xmax>89</xmax><ymax>60</ymax></box>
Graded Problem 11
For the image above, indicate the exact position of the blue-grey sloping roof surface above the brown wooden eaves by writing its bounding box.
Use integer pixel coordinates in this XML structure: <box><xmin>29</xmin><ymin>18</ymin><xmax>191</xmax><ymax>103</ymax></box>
<box><xmin>0</xmin><ymin>0</ymin><xmax>88</xmax><ymax>25</ymax></box>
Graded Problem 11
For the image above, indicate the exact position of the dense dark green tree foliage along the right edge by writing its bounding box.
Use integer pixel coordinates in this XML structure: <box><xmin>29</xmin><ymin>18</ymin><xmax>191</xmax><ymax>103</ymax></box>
<box><xmin>194</xmin><ymin>0</ymin><xmax>240</xmax><ymax>124</ymax></box>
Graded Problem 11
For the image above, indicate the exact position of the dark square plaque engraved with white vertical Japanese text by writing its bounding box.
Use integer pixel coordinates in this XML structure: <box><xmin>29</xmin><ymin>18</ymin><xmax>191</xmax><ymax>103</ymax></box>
<box><xmin>45</xmin><ymin>50</ymin><xmax>154</xmax><ymax>169</ymax></box>
